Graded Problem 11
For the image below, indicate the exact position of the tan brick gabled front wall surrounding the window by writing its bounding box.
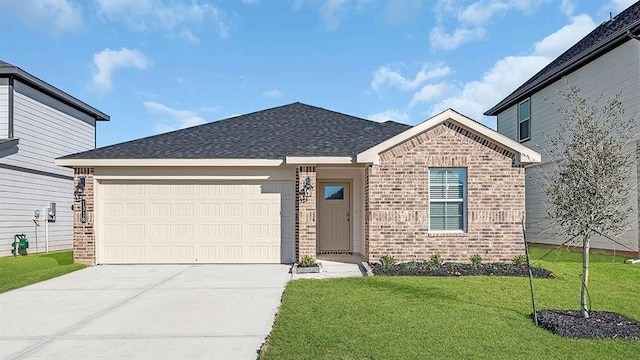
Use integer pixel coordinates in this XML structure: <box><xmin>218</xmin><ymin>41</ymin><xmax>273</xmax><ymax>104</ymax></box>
<box><xmin>365</xmin><ymin>122</ymin><xmax>525</xmax><ymax>262</ymax></box>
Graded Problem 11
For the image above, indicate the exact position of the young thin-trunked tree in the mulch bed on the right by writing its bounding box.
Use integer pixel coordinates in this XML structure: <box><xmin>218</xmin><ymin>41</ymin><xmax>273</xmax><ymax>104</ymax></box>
<box><xmin>545</xmin><ymin>86</ymin><xmax>636</xmax><ymax>318</ymax></box>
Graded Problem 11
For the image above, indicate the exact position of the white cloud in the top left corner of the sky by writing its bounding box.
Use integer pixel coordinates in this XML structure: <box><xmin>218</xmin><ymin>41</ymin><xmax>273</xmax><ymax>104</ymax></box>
<box><xmin>0</xmin><ymin>0</ymin><xmax>83</xmax><ymax>33</ymax></box>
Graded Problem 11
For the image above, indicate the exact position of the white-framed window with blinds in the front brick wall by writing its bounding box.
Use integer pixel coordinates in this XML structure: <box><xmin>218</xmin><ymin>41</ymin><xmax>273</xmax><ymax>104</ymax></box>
<box><xmin>429</xmin><ymin>168</ymin><xmax>467</xmax><ymax>231</ymax></box>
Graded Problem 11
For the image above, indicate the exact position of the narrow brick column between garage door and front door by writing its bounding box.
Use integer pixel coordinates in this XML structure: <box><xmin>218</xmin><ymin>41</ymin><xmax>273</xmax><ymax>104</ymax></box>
<box><xmin>296</xmin><ymin>165</ymin><xmax>318</xmax><ymax>260</ymax></box>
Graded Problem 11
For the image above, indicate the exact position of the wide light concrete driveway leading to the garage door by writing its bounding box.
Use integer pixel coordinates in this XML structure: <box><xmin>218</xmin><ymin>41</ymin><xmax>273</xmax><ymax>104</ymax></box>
<box><xmin>0</xmin><ymin>265</ymin><xmax>290</xmax><ymax>359</ymax></box>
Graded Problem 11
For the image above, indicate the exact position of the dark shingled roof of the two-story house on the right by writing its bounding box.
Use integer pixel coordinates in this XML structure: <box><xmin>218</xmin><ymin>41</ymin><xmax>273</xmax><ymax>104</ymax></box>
<box><xmin>484</xmin><ymin>1</ymin><xmax>640</xmax><ymax>116</ymax></box>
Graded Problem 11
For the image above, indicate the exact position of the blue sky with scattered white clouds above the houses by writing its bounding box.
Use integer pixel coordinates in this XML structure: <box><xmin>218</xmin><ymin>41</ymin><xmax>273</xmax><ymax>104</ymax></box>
<box><xmin>0</xmin><ymin>0</ymin><xmax>635</xmax><ymax>146</ymax></box>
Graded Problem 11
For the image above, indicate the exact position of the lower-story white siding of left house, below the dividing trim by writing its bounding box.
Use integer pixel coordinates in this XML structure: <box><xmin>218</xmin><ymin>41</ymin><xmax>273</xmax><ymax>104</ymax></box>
<box><xmin>0</xmin><ymin>168</ymin><xmax>73</xmax><ymax>256</ymax></box>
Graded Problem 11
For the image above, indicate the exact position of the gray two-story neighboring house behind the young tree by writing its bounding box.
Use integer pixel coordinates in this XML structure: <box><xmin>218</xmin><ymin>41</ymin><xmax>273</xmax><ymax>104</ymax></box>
<box><xmin>485</xmin><ymin>2</ymin><xmax>640</xmax><ymax>253</ymax></box>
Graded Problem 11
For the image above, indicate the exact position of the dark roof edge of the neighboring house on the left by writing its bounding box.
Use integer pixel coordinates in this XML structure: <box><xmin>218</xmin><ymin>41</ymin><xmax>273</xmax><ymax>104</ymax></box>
<box><xmin>0</xmin><ymin>60</ymin><xmax>109</xmax><ymax>121</ymax></box>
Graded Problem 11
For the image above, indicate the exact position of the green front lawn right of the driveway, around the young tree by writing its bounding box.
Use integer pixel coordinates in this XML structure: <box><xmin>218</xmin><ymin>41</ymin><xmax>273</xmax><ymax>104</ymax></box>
<box><xmin>261</xmin><ymin>248</ymin><xmax>640</xmax><ymax>360</ymax></box>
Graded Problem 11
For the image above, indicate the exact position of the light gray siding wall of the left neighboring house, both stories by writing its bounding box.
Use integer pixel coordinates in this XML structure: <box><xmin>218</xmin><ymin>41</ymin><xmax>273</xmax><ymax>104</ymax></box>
<box><xmin>0</xmin><ymin>81</ymin><xmax>95</xmax><ymax>256</ymax></box>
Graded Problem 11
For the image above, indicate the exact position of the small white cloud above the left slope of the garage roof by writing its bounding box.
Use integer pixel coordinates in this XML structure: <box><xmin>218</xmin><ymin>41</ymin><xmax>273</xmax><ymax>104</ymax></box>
<box><xmin>93</xmin><ymin>48</ymin><xmax>151</xmax><ymax>91</ymax></box>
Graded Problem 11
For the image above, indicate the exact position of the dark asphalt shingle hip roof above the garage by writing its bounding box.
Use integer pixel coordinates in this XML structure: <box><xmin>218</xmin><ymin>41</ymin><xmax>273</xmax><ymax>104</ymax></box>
<box><xmin>62</xmin><ymin>102</ymin><xmax>411</xmax><ymax>159</ymax></box>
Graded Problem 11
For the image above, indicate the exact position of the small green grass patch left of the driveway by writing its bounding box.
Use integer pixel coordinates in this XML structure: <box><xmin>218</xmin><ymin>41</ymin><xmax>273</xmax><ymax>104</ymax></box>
<box><xmin>0</xmin><ymin>251</ymin><xmax>85</xmax><ymax>293</ymax></box>
